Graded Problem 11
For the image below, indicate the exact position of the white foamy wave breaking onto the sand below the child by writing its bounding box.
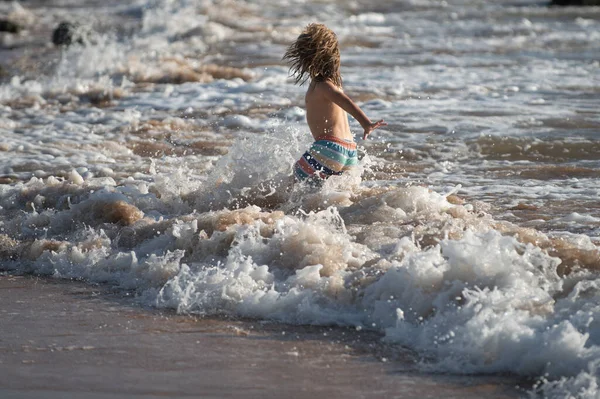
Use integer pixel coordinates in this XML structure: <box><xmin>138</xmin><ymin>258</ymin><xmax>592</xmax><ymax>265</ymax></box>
<box><xmin>0</xmin><ymin>136</ymin><xmax>598</xmax><ymax>396</ymax></box>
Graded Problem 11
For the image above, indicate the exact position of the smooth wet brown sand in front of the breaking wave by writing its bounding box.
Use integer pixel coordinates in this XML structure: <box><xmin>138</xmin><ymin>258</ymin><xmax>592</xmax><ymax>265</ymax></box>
<box><xmin>0</xmin><ymin>275</ymin><xmax>522</xmax><ymax>399</ymax></box>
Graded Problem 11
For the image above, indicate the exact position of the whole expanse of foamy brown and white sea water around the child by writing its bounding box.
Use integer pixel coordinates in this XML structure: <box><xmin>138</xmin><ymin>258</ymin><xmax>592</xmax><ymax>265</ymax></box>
<box><xmin>0</xmin><ymin>0</ymin><xmax>600</xmax><ymax>398</ymax></box>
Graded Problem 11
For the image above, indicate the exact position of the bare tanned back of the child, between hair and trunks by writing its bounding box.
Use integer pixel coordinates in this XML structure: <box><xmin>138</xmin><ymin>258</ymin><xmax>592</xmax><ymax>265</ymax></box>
<box><xmin>304</xmin><ymin>81</ymin><xmax>353</xmax><ymax>140</ymax></box>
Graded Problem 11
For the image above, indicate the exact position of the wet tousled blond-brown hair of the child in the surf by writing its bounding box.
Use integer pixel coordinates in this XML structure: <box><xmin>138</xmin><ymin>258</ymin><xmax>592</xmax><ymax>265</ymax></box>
<box><xmin>283</xmin><ymin>24</ymin><xmax>342</xmax><ymax>87</ymax></box>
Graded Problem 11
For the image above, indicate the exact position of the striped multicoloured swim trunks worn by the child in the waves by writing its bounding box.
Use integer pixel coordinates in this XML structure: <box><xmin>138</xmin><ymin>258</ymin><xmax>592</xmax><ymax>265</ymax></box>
<box><xmin>294</xmin><ymin>136</ymin><xmax>358</xmax><ymax>181</ymax></box>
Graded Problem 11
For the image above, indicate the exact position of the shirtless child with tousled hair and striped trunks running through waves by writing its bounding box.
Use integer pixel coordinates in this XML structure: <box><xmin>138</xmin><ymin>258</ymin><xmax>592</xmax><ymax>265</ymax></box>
<box><xmin>283</xmin><ymin>24</ymin><xmax>387</xmax><ymax>181</ymax></box>
